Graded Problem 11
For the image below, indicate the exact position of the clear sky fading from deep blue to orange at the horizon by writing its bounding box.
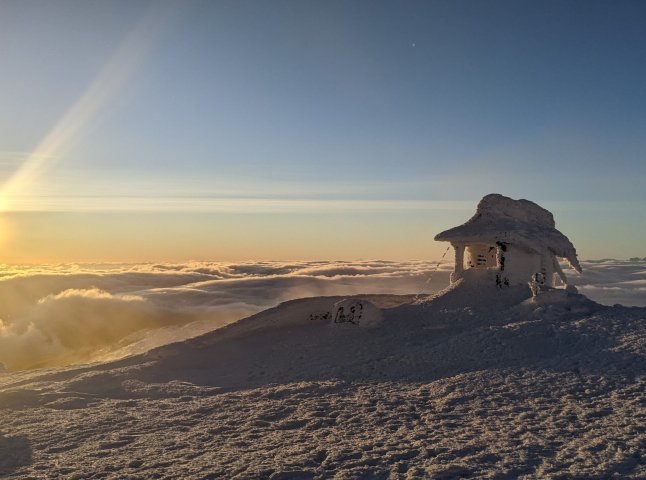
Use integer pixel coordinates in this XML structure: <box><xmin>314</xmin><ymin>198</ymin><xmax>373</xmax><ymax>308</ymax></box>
<box><xmin>0</xmin><ymin>0</ymin><xmax>646</xmax><ymax>263</ymax></box>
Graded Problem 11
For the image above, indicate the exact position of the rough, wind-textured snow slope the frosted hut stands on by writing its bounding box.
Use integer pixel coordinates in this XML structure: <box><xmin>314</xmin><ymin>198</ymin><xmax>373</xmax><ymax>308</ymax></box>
<box><xmin>0</xmin><ymin>282</ymin><xmax>646</xmax><ymax>479</ymax></box>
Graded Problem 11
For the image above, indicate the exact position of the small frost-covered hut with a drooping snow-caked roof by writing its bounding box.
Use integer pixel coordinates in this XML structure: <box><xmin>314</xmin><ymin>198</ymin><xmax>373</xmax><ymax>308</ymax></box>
<box><xmin>435</xmin><ymin>193</ymin><xmax>581</xmax><ymax>287</ymax></box>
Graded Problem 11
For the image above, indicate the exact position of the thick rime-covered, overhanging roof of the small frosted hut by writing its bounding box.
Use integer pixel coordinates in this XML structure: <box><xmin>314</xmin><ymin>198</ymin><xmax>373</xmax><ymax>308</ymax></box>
<box><xmin>435</xmin><ymin>193</ymin><xmax>581</xmax><ymax>272</ymax></box>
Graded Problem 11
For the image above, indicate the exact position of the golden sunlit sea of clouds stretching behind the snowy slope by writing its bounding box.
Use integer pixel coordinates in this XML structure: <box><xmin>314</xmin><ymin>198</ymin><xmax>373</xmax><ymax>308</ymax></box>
<box><xmin>0</xmin><ymin>259</ymin><xmax>646</xmax><ymax>370</ymax></box>
